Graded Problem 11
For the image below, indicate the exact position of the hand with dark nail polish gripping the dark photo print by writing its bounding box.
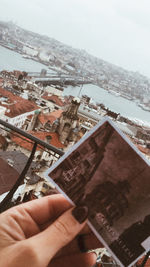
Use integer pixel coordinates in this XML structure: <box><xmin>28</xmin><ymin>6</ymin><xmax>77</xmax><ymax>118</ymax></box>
<box><xmin>0</xmin><ymin>194</ymin><xmax>101</xmax><ymax>267</ymax></box>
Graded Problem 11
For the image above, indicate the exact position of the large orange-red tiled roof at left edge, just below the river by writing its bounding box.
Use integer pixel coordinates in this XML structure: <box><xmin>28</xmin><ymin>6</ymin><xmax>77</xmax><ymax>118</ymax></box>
<box><xmin>0</xmin><ymin>88</ymin><xmax>38</xmax><ymax>118</ymax></box>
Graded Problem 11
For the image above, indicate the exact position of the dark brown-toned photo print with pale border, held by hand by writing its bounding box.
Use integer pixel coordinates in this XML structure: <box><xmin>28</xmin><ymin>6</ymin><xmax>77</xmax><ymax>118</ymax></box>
<box><xmin>48</xmin><ymin>119</ymin><xmax>150</xmax><ymax>266</ymax></box>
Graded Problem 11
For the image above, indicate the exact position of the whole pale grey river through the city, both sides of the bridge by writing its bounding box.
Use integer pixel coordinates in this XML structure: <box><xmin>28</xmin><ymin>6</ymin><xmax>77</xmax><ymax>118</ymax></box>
<box><xmin>0</xmin><ymin>46</ymin><xmax>150</xmax><ymax>125</ymax></box>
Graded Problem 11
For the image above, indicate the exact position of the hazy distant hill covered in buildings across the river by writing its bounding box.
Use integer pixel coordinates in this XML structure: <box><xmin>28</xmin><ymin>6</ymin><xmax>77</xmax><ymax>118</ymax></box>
<box><xmin>0</xmin><ymin>21</ymin><xmax>150</xmax><ymax>108</ymax></box>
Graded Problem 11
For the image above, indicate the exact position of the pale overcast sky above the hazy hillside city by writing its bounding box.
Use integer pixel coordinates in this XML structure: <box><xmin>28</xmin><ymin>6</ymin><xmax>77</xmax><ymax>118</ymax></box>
<box><xmin>0</xmin><ymin>0</ymin><xmax>150</xmax><ymax>77</ymax></box>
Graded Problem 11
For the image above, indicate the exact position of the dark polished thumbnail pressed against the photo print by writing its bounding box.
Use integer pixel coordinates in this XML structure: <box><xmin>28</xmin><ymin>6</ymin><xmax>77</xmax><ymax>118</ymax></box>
<box><xmin>72</xmin><ymin>206</ymin><xmax>88</xmax><ymax>223</ymax></box>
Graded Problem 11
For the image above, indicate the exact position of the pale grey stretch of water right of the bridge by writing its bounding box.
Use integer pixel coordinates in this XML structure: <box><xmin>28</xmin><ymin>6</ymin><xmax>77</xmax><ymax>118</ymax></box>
<box><xmin>64</xmin><ymin>84</ymin><xmax>150</xmax><ymax>126</ymax></box>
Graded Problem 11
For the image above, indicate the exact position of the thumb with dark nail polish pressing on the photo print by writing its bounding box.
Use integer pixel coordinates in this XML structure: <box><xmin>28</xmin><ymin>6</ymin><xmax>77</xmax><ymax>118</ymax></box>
<box><xmin>27</xmin><ymin>206</ymin><xmax>88</xmax><ymax>264</ymax></box>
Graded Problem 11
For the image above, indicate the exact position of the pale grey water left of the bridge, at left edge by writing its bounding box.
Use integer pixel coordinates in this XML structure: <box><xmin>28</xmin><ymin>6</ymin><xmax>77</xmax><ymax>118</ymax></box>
<box><xmin>0</xmin><ymin>46</ymin><xmax>50</xmax><ymax>72</ymax></box>
